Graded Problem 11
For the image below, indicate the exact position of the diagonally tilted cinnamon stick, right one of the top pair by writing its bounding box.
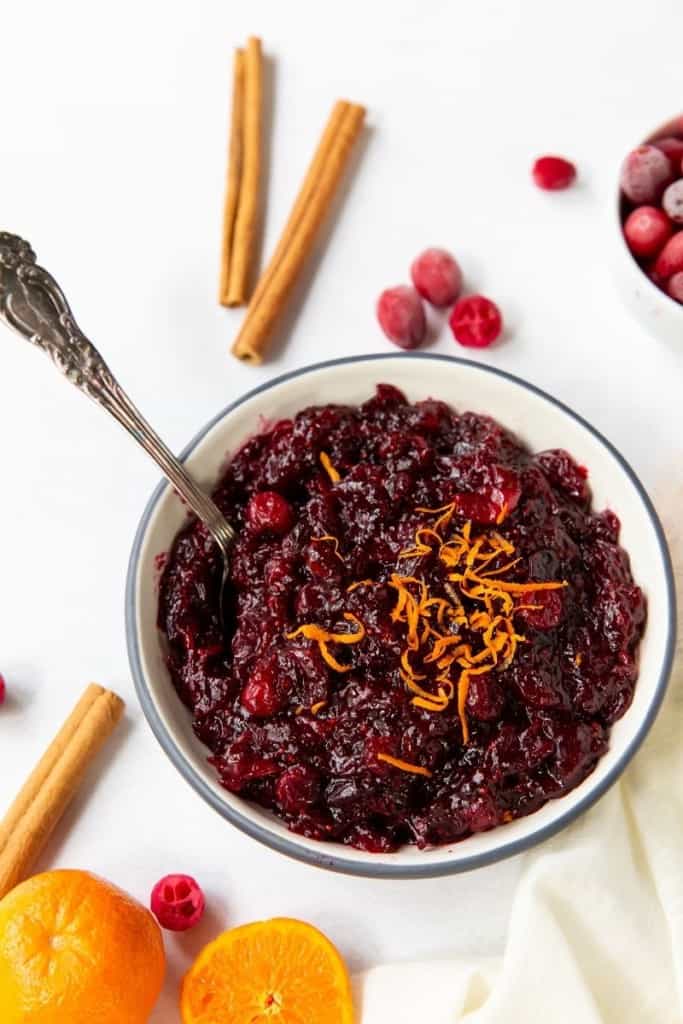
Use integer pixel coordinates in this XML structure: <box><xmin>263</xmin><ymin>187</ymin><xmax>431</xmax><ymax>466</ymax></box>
<box><xmin>232</xmin><ymin>103</ymin><xmax>366</xmax><ymax>364</ymax></box>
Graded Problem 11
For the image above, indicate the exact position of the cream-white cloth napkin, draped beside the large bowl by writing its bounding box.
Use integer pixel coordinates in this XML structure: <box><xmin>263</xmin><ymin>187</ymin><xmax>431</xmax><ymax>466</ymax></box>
<box><xmin>356</xmin><ymin>520</ymin><xmax>683</xmax><ymax>1024</ymax></box>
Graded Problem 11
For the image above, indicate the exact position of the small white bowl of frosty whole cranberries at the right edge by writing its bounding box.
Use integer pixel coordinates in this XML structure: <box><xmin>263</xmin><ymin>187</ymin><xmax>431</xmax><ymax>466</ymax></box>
<box><xmin>616</xmin><ymin>116</ymin><xmax>683</xmax><ymax>343</ymax></box>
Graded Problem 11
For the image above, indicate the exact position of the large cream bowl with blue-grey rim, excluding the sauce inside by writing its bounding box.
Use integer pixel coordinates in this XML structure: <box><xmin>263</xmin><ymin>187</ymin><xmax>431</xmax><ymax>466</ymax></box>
<box><xmin>127</xmin><ymin>355</ymin><xmax>675</xmax><ymax>877</ymax></box>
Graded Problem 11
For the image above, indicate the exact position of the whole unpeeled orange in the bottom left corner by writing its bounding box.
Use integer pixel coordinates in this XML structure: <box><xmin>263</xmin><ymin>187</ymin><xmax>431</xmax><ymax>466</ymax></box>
<box><xmin>0</xmin><ymin>871</ymin><xmax>166</xmax><ymax>1024</ymax></box>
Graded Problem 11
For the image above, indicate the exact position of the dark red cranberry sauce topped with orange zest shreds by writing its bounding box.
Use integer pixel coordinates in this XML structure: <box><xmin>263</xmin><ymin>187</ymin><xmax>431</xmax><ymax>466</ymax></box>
<box><xmin>159</xmin><ymin>385</ymin><xmax>645</xmax><ymax>852</ymax></box>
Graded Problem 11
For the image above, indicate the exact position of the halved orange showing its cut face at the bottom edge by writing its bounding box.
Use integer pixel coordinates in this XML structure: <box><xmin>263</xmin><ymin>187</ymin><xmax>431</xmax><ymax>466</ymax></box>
<box><xmin>180</xmin><ymin>918</ymin><xmax>353</xmax><ymax>1024</ymax></box>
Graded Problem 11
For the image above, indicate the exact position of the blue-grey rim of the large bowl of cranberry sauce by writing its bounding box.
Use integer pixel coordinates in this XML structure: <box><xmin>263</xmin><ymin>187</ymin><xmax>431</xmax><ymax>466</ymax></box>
<box><xmin>126</xmin><ymin>352</ymin><xmax>676</xmax><ymax>879</ymax></box>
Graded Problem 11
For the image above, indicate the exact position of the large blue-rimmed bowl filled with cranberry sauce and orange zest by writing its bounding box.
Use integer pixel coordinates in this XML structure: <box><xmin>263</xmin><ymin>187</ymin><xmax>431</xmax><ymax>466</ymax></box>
<box><xmin>127</xmin><ymin>354</ymin><xmax>675</xmax><ymax>878</ymax></box>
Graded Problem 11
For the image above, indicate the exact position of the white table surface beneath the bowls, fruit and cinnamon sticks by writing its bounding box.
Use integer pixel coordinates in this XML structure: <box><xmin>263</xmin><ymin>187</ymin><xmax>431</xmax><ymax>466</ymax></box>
<box><xmin>0</xmin><ymin>0</ymin><xmax>683</xmax><ymax>1022</ymax></box>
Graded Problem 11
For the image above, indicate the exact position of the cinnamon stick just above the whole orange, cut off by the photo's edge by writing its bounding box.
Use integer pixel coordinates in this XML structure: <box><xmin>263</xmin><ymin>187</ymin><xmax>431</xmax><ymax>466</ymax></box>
<box><xmin>0</xmin><ymin>684</ymin><xmax>124</xmax><ymax>899</ymax></box>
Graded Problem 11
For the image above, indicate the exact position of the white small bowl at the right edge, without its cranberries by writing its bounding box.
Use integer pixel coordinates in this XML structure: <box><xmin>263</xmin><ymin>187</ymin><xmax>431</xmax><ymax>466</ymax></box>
<box><xmin>607</xmin><ymin>118</ymin><xmax>683</xmax><ymax>349</ymax></box>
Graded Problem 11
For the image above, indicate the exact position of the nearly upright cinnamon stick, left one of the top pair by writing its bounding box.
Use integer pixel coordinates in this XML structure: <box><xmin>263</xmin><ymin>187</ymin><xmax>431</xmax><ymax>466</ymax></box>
<box><xmin>224</xmin><ymin>36</ymin><xmax>263</xmax><ymax>306</ymax></box>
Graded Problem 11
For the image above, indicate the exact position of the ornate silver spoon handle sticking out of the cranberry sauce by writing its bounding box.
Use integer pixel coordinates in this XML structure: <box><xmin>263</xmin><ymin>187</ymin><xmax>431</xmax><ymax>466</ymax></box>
<box><xmin>0</xmin><ymin>231</ymin><xmax>237</xmax><ymax>623</ymax></box>
